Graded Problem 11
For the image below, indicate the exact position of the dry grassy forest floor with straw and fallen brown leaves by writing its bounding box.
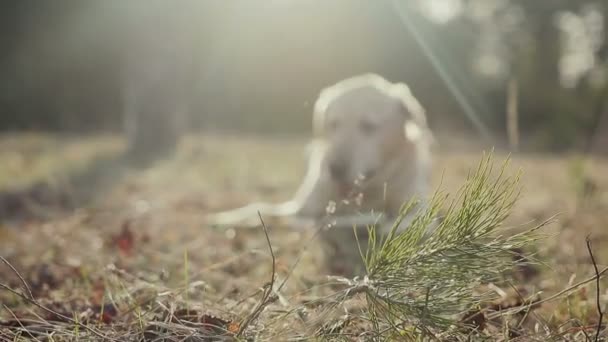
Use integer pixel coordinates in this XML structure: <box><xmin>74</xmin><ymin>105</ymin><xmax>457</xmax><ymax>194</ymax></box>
<box><xmin>0</xmin><ymin>134</ymin><xmax>608</xmax><ymax>340</ymax></box>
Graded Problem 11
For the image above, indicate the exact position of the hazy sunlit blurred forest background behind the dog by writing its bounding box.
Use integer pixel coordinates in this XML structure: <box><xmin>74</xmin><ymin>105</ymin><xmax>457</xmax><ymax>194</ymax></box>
<box><xmin>0</xmin><ymin>0</ymin><xmax>608</xmax><ymax>150</ymax></box>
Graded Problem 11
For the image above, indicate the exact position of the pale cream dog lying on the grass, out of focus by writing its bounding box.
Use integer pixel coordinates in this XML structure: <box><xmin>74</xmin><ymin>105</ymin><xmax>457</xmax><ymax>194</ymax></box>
<box><xmin>207</xmin><ymin>73</ymin><xmax>434</xmax><ymax>234</ymax></box>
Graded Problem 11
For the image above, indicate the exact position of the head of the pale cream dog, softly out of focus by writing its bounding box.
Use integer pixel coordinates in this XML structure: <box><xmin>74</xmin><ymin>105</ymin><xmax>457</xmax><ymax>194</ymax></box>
<box><xmin>313</xmin><ymin>74</ymin><xmax>430</xmax><ymax>190</ymax></box>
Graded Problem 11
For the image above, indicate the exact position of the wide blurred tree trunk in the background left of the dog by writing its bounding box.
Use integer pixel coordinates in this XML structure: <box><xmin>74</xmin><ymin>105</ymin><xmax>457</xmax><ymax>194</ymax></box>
<box><xmin>120</xmin><ymin>1</ymin><xmax>196</xmax><ymax>162</ymax></box>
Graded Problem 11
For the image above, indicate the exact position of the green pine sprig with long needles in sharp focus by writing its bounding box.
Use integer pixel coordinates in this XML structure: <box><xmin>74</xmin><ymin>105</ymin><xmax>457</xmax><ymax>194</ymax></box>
<box><xmin>358</xmin><ymin>154</ymin><xmax>542</xmax><ymax>332</ymax></box>
